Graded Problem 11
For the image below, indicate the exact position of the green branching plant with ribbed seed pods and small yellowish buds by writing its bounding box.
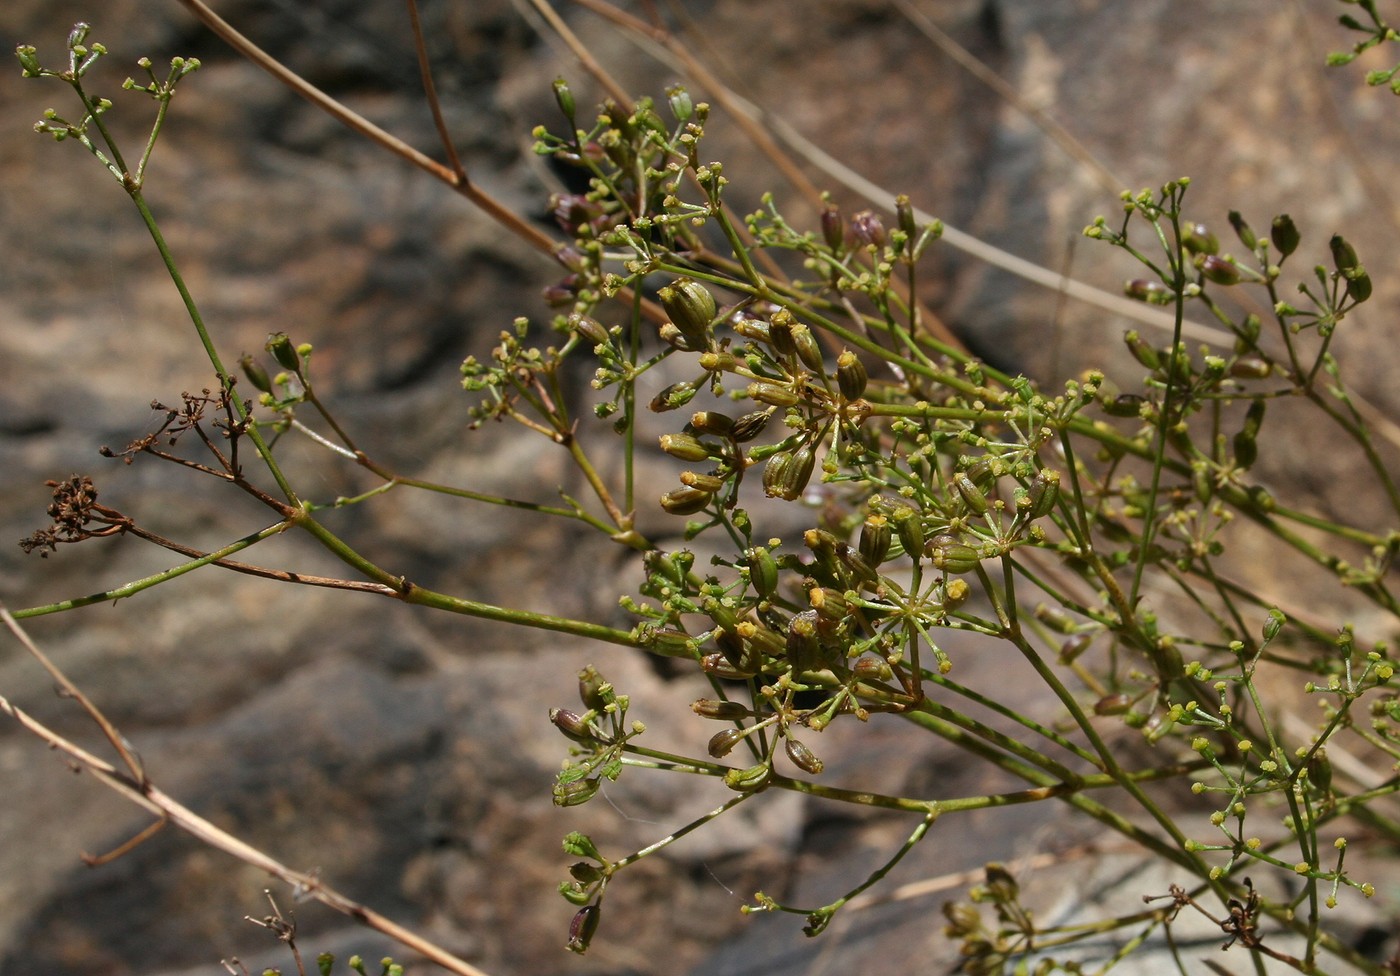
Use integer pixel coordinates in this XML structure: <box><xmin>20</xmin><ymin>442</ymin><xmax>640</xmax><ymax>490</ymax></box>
<box><xmin>8</xmin><ymin>1</ymin><xmax>1400</xmax><ymax>975</ymax></box>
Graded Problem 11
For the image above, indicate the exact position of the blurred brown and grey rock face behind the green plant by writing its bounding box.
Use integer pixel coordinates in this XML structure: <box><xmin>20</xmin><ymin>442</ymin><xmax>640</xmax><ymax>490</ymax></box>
<box><xmin>0</xmin><ymin>0</ymin><xmax>1400</xmax><ymax>976</ymax></box>
